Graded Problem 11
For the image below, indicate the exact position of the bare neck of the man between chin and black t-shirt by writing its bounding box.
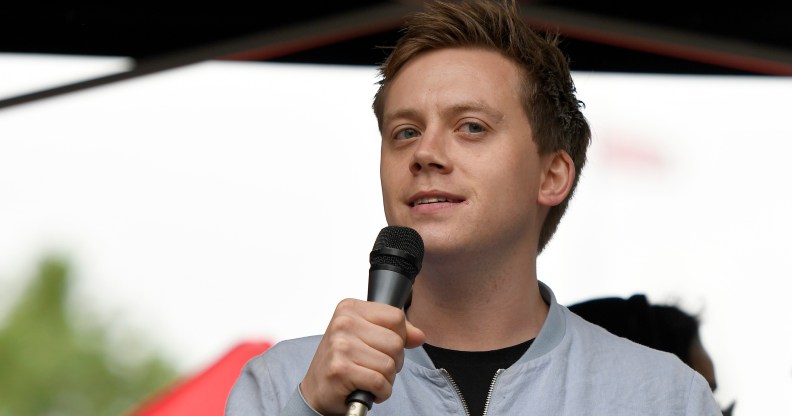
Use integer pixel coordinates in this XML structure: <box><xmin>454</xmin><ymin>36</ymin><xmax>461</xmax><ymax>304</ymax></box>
<box><xmin>407</xmin><ymin>256</ymin><xmax>548</xmax><ymax>351</ymax></box>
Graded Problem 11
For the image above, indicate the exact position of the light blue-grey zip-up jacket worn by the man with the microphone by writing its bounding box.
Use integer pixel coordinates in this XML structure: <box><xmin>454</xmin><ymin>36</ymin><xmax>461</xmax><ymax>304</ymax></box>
<box><xmin>226</xmin><ymin>283</ymin><xmax>721</xmax><ymax>416</ymax></box>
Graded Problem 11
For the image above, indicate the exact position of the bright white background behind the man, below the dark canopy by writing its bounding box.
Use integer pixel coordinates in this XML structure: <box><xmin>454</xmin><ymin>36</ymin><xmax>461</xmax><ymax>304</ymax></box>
<box><xmin>0</xmin><ymin>55</ymin><xmax>792</xmax><ymax>415</ymax></box>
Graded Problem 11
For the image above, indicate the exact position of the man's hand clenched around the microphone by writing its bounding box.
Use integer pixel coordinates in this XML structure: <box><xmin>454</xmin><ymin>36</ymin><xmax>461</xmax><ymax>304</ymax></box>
<box><xmin>300</xmin><ymin>299</ymin><xmax>426</xmax><ymax>415</ymax></box>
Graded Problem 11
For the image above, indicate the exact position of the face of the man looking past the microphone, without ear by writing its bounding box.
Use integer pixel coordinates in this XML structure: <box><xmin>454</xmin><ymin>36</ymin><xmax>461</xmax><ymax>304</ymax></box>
<box><xmin>380</xmin><ymin>48</ymin><xmax>549</xmax><ymax>260</ymax></box>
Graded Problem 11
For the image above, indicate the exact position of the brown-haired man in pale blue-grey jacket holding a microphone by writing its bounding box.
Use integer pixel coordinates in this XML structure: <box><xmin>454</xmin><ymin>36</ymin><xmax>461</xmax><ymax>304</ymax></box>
<box><xmin>227</xmin><ymin>0</ymin><xmax>719</xmax><ymax>416</ymax></box>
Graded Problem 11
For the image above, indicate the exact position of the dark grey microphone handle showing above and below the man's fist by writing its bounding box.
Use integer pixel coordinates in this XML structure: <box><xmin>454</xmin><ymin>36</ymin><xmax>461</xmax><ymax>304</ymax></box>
<box><xmin>346</xmin><ymin>268</ymin><xmax>412</xmax><ymax>416</ymax></box>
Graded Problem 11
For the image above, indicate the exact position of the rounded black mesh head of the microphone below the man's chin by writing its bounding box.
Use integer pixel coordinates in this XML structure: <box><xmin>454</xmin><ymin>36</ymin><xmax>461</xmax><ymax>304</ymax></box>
<box><xmin>369</xmin><ymin>225</ymin><xmax>424</xmax><ymax>280</ymax></box>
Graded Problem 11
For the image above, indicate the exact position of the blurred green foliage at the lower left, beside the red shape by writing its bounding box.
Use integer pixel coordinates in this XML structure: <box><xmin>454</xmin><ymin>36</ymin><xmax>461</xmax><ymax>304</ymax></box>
<box><xmin>0</xmin><ymin>258</ymin><xmax>178</xmax><ymax>416</ymax></box>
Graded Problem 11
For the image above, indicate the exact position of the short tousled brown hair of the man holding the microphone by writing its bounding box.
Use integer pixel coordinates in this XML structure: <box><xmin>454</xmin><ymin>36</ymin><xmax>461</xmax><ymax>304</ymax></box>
<box><xmin>372</xmin><ymin>0</ymin><xmax>591</xmax><ymax>252</ymax></box>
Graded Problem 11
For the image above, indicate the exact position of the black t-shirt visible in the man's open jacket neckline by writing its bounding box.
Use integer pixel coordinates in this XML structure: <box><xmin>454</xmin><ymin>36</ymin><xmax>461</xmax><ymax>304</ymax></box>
<box><xmin>423</xmin><ymin>339</ymin><xmax>533</xmax><ymax>415</ymax></box>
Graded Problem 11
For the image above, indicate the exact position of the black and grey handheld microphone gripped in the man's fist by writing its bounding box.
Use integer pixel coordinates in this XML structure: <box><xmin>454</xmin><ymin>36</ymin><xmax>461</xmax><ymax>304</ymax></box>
<box><xmin>346</xmin><ymin>225</ymin><xmax>424</xmax><ymax>416</ymax></box>
